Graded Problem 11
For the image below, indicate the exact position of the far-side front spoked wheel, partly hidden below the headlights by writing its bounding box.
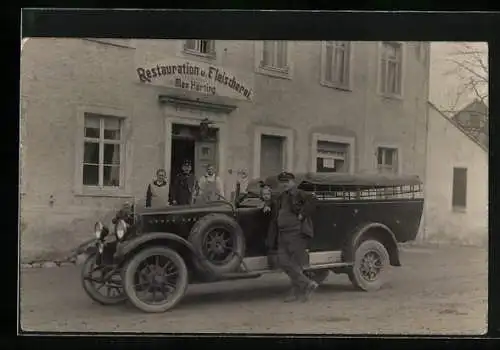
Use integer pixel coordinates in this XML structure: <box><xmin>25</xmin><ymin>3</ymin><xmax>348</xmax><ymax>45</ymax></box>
<box><xmin>81</xmin><ymin>254</ymin><xmax>127</xmax><ymax>305</ymax></box>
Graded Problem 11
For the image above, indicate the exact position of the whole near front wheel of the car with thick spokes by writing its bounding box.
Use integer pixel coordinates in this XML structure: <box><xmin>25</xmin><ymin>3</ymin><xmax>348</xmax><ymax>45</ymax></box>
<box><xmin>123</xmin><ymin>247</ymin><xmax>188</xmax><ymax>313</ymax></box>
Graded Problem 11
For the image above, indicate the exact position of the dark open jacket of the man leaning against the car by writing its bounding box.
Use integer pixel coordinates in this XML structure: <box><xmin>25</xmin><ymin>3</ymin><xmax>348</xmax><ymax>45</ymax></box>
<box><xmin>266</xmin><ymin>189</ymin><xmax>316</xmax><ymax>249</ymax></box>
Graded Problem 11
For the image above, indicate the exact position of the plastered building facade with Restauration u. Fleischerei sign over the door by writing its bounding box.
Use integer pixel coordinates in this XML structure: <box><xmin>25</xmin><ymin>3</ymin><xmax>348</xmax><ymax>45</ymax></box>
<box><xmin>20</xmin><ymin>38</ymin><xmax>429</xmax><ymax>260</ymax></box>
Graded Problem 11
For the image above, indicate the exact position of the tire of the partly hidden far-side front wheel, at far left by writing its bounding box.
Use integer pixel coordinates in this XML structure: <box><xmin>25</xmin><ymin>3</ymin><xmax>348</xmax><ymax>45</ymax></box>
<box><xmin>81</xmin><ymin>254</ymin><xmax>127</xmax><ymax>305</ymax></box>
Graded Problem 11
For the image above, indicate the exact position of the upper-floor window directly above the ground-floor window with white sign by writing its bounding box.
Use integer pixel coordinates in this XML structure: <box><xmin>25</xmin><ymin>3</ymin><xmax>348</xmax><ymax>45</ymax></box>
<box><xmin>323</xmin><ymin>41</ymin><xmax>351</xmax><ymax>88</ymax></box>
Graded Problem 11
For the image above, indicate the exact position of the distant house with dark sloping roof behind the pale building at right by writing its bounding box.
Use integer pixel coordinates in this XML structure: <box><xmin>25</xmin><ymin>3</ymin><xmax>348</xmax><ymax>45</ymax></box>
<box><xmin>452</xmin><ymin>99</ymin><xmax>489</xmax><ymax>147</ymax></box>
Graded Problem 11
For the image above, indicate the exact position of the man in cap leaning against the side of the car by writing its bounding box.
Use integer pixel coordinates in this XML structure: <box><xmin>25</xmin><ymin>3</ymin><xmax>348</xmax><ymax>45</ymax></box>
<box><xmin>269</xmin><ymin>172</ymin><xmax>318</xmax><ymax>302</ymax></box>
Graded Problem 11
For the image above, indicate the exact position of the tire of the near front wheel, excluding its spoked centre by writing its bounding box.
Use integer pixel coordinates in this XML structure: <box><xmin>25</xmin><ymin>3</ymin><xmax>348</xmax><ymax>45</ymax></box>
<box><xmin>123</xmin><ymin>247</ymin><xmax>188</xmax><ymax>313</ymax></box>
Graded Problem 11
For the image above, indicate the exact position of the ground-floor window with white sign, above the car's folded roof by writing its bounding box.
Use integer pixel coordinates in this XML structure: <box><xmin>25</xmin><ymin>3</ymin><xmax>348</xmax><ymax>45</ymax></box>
<box><xmin>316</xmin><ymin>141</ymin><xmax>349</xmax><ymax>173</ymax></box>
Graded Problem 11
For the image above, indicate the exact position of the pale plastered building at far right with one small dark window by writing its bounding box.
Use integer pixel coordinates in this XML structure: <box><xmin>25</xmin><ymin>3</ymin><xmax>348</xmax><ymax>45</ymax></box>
<box><xmin>424</xmin><ymin>103</ymin><xmax>488</xmax><ymax>245</ymax></box>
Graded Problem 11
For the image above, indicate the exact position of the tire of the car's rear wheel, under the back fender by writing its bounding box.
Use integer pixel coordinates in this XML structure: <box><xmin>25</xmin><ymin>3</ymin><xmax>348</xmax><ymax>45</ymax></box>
<box><xmin>347</xmin><ymin>239</ymin><xmax>390</xmax><ymax>292</ymax></box>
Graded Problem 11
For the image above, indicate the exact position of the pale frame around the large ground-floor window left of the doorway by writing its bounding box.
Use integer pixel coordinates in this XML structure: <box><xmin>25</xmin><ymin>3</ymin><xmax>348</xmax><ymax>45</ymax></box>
<box><xmin>74</xmin><ymin>105</ymin><xmax>132</xmax><ymax>197</ymax></box>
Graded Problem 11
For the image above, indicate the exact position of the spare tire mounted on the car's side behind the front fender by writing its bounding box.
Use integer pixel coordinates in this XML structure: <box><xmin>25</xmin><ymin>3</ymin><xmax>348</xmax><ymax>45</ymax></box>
<box><xmin>189</xmin><ymin>214</ymin><xmax>245</xmax><ymax>275</ymax></box>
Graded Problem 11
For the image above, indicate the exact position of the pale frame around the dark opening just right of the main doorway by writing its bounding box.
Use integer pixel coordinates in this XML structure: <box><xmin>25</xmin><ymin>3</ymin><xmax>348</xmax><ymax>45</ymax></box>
<box><xmin>253</xmin><ymin>126</ymin><xmax>294</xmax><ymax>179</ymax></box>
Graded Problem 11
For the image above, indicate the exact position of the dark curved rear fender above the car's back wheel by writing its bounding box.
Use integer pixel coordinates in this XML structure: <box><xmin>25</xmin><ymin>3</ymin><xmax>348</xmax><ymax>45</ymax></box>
<box><xmin>342</xmin><ymin>222</ymin><xmax>401</xmax><ymax>266</ymax></box>
